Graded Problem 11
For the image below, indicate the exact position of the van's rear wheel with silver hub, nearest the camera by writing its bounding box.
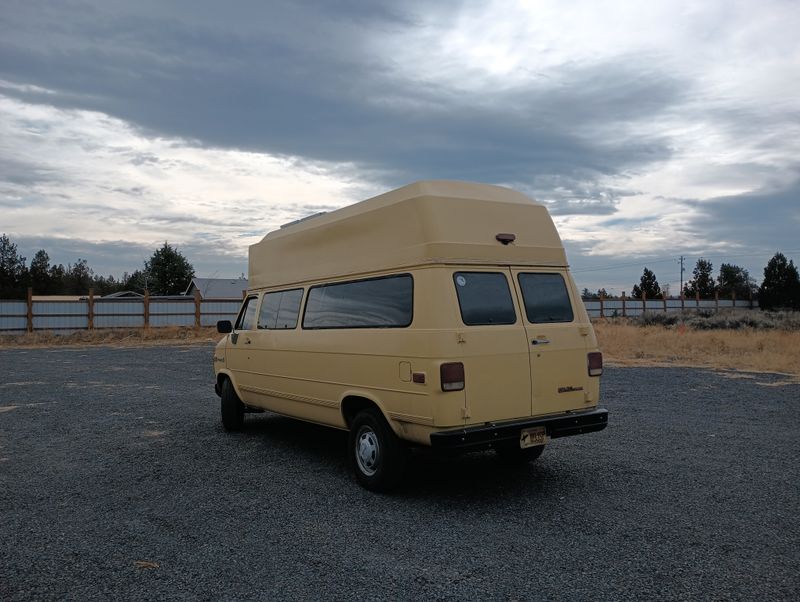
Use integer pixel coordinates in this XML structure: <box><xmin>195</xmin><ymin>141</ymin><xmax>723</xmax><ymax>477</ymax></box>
<box><xmin>348</xmin><ymin>408</ymin><xmax>409</xmax><ymax>491</ymax></box>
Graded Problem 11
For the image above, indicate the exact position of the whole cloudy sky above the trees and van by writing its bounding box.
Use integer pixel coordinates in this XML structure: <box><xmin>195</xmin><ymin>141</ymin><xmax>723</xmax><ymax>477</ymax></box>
<box><xmin>0</xmin><ymin>0</ymin><xmax>800</xmax><ymax>294</ymax></box>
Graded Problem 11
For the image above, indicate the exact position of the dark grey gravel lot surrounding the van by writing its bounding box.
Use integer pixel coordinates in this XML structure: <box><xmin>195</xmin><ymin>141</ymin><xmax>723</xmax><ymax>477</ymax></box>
<box><xmin>0</xmin><ymin>345</ymin><xmax>800</xmax><ymax>600</ymax></box>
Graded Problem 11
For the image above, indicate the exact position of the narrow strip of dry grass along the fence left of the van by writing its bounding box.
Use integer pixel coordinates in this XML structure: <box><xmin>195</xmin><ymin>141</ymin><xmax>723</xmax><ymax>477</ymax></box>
<box><xmin>0</xmin><ymin>326</ymin><xmax>222</xmax><ymax>348</ymax></box>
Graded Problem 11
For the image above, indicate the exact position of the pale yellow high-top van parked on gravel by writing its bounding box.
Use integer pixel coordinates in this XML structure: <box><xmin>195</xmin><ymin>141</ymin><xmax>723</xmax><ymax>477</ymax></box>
<box><xmin>214</xmin><ymin>181</ymin><xmax>608</xmax><ymax>490</ymax></box>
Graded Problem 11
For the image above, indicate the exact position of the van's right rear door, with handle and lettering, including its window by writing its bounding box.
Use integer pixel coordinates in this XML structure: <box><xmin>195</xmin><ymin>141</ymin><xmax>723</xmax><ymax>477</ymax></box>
<box><xmin>512</xmin><ymin>269</ymin><xmax>588</xmax><ymax>416</ymax></box>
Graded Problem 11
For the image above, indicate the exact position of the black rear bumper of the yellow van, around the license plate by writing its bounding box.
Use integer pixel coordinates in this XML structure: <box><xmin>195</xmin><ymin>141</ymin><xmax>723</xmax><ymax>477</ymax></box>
<box><xmin>431</xmin><ymin>408</ymin><xmax>608</xmax><ymax>450</ymax></box>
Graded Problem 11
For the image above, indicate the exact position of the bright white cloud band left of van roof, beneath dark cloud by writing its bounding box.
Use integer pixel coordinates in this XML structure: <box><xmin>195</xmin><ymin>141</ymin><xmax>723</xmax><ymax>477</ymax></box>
<box><xmin>0</xmin><ymin>96</ymin><xmax>364</xmax><ymax>271</ymax></box>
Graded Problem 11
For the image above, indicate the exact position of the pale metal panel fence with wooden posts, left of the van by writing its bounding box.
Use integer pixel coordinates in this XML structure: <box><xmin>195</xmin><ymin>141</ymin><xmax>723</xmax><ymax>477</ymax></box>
<box><xmin>0</xmin><ymin>295</ymin><xmax>242</xmax><ymax>335</ymax></box>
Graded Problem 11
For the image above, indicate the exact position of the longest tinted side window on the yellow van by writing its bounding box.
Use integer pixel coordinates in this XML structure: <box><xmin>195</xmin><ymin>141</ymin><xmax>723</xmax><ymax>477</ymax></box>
<box><xmin>303</xmin><ymin>274</ymin><xmax>414</xmax><ymax>329</ymax></box>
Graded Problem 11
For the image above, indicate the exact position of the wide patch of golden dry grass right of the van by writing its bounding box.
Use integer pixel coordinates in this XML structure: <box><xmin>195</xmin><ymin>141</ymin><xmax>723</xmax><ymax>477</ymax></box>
<box><xmin>594</xmin><ymin>320</ymin><xmax>800</xmax><ymax>376</ymax></box>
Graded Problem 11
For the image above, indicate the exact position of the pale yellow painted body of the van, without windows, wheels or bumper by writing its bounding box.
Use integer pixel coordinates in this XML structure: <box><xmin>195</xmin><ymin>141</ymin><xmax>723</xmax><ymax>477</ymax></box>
<box><xmin>214</xmin><ymin>181</ymin><xmax>599</xmax><ymax>444</ymax></box>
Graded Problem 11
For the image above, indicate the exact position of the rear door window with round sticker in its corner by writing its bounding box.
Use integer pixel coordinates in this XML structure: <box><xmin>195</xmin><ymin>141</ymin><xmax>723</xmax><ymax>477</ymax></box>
<box><xmin>453</xmin><ymin>272</ymin><xmax>517</xmax><ymax>326</ymax></box>
